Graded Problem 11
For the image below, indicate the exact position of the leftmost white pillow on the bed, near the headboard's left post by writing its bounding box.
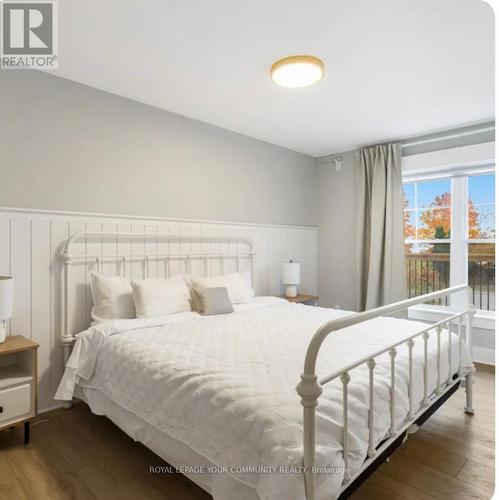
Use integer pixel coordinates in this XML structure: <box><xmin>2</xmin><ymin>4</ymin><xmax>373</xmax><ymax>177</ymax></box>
<box><xmin>90</xmin><ymin>273</ymin><xmax>135</xmax><ymax>323</ymax></box>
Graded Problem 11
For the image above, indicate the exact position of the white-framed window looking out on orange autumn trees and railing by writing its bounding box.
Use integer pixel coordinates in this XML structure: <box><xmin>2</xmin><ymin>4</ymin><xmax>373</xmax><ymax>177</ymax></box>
<box><xmin>404</xmin><ymin>173</ymin><xmax>495</xmax><ymax>311</ymax></box>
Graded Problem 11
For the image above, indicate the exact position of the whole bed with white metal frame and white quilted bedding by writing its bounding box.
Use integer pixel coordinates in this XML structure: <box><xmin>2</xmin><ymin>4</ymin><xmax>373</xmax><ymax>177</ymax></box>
<box><xmin>56</xmin><ymin>233</ymin><xmax>473</xmax><ymax>500</ymax></box>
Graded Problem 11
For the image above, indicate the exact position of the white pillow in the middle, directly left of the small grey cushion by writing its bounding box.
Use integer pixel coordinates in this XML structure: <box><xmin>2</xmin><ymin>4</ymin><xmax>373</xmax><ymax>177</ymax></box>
<box><xmin>132</xmin><ymin>275</ymin><xmax>191</xmax><ymax>318</ymax></box>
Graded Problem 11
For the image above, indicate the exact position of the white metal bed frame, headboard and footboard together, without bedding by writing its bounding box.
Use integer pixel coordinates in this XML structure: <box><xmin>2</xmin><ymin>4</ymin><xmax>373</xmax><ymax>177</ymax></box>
<box><xmin>61</xmin><ymin>231</ymin><xmax>475</xmax><ymax>500</ymax></box>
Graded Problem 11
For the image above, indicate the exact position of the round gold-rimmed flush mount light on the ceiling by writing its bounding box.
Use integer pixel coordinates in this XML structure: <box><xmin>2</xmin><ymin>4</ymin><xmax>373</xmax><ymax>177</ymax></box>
<box><xmin>270</xmin><ymin>56</ymin><xmax>324</xmax><ymax>88</ymax></box>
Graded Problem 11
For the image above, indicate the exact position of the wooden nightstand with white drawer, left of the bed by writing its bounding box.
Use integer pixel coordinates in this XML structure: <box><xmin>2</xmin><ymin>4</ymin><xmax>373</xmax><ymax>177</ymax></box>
<box><xmin>0</xmin><ymin>335</ymin><xmax>38</xmax><ymax>444</ymax></box>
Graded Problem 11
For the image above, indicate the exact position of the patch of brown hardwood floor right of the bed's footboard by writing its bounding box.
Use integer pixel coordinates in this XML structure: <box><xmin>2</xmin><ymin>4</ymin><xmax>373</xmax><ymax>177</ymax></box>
<box><xmin>352</xmin><ymin>366</ymin><xmax>495</xmax><ymax>500</ymax></box>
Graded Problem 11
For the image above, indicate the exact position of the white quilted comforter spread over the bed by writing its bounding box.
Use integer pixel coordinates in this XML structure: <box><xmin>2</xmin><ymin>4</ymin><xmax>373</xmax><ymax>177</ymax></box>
<box><xmin>56</xmin><ymin>298</ymin><xmax>470</xmax><ymax>500</ymax></box>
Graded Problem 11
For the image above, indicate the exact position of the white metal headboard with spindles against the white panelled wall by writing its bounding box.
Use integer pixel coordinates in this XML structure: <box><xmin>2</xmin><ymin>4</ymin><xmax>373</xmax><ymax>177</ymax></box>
<box><xmin>61</xmin><ymin>231</ymin><xmax>256</xmax><ymax>361</ymax></box>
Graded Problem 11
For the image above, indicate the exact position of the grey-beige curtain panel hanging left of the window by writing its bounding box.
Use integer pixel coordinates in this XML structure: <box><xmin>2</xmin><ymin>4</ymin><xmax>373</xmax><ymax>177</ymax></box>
<box><xmin>358</xmin><ymin>144</ymin><xmax>407</xmax><ymax>310</ymax></box>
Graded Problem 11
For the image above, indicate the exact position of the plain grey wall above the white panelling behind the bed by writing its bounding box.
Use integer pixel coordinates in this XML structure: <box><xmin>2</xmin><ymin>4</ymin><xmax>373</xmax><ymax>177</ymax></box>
<box><xmin>0</xmin><ymin>71</ymin><xmax>317</xmax><ymax>225</ymax></box>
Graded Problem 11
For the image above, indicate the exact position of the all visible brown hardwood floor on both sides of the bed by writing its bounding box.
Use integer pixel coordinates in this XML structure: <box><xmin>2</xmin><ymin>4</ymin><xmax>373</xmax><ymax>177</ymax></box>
<box><xmin>0</xmin><ymin>366</ymin><xmax>494</xmax><ymax>500</ymax></box>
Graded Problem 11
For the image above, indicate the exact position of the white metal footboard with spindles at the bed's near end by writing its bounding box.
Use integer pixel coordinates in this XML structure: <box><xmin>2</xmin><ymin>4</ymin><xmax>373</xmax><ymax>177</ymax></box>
<box><xmin>296</xmin><ymin>285</ymin><xmax>475</xmax><ymax>500</ymax></box>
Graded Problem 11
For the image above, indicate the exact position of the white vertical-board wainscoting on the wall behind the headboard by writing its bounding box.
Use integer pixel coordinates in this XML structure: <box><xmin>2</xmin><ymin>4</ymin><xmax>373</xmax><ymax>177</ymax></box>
<box><xmin>0</xmin><ymin>208</ymin><xmax>317</xmax><ymax>411</ymax></box>
